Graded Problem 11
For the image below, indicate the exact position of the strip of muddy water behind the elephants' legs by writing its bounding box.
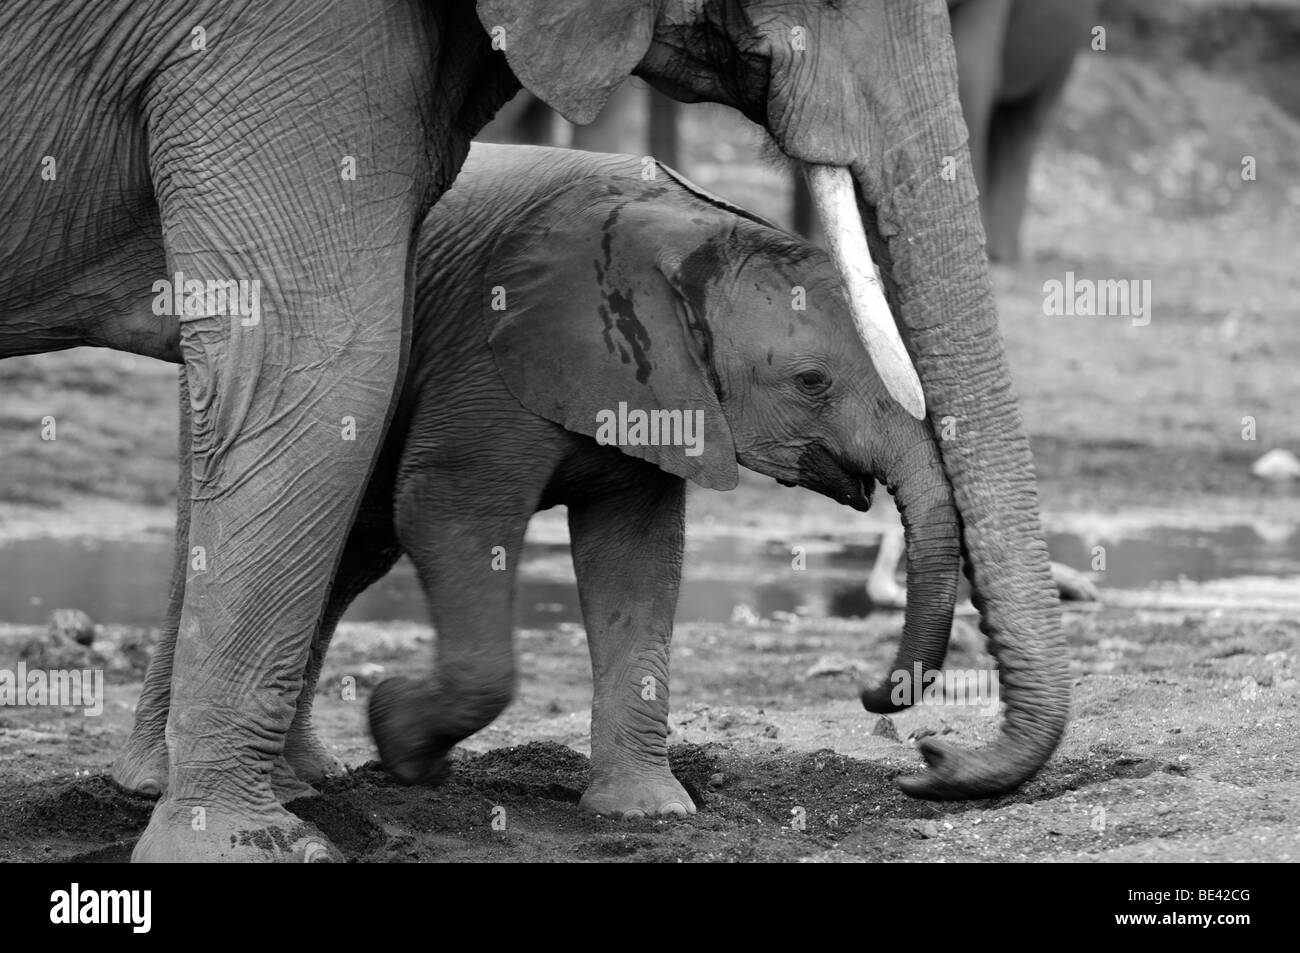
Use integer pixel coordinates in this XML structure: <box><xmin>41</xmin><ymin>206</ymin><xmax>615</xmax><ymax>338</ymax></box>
<box><xmin>0</xmin><ymin>525</ymin><xmax>1300</xmax><ymax>627</ymax></box>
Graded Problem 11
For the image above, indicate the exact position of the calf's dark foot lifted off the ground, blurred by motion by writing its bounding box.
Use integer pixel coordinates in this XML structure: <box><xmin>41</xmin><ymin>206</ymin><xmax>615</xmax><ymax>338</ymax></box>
<box><xmin>371</xmin><ymin>677</ymin><xmax>451</xmax><ymax>784</ymax></box>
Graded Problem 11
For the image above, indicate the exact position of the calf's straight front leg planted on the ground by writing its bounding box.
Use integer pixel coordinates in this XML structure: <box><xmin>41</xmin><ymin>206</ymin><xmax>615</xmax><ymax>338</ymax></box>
<box><xmin>569</xmin><ymin>465</ymin><xmax>696</xmax><ymax>818</ymax></box>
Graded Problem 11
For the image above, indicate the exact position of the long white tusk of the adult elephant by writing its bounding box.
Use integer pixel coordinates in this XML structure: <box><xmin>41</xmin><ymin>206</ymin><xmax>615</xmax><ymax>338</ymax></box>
<box><xmin>803</xmin><ymin>165</ymin><xmax>926</xmax><ymax>420</ymax></box>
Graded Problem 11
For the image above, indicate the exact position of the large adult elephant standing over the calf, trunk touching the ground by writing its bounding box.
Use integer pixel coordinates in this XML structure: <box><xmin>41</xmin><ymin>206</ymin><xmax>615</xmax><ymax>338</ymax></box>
<box><xmin>0</xmin><ymin>0</ymin><xmax>1069</xmax><ymax>859</ymax></box>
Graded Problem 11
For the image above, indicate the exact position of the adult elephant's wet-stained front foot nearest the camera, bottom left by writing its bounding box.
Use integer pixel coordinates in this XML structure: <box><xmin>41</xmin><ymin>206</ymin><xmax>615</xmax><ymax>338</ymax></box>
<box><xmin>131</xmin><ymin>800</ymin><xmax>343</xmax><ymax>863</ymax></box>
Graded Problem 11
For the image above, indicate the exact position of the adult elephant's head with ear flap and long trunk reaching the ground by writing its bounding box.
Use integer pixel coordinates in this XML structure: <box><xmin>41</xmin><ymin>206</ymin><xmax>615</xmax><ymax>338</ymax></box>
<box><xmin>478</xmin><ymin>0</ymin><xmax>1069</xmax><ymax>798</ymax></box>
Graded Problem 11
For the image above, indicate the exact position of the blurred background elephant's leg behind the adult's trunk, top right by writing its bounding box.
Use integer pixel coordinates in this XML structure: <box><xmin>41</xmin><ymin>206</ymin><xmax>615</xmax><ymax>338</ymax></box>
<box><xmin>948</xmin><ymin>0</ymin><xmax>1101</xmax><ymax>261</ymax></box>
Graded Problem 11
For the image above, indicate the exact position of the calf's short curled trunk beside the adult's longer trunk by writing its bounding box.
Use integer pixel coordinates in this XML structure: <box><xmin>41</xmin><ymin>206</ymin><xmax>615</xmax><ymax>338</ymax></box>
<box><xmin>862</xmin><ymin>424</ymin><xmax>962</xmax><ymax>714</ymax></box>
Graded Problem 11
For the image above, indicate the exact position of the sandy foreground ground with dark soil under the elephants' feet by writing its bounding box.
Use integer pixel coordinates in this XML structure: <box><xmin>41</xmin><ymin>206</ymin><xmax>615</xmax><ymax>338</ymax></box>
<box><xmin>0</xmin><ymin>610</ymin><xmax>1300</xmax><ymax>862</ymax></box>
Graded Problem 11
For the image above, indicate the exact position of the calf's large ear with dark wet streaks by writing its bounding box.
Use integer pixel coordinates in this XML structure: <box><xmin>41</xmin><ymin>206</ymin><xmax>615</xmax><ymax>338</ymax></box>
<box><xmin>484</xmin><ymin>182</ymin><xmax>738</xmax><ymax>490</ymax></box>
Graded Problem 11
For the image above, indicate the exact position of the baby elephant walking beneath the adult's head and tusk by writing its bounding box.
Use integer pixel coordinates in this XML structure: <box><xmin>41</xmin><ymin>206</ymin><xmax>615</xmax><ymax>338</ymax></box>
<box><xmin>116</xmin><ymin>146</ymin><xmax>961</xmax><ymax>816</ymax></box>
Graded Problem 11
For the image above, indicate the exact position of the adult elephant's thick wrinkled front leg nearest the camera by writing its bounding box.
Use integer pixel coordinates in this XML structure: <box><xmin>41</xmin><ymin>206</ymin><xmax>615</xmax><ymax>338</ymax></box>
<box><xmin>135</xmin><ymin>276</ymin><xmax>406</xmax><ymax>861</ymax></box>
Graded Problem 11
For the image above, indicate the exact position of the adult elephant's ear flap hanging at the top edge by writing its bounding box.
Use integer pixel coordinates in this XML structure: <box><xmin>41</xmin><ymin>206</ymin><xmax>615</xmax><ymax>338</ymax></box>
<box><xmin>478</xmin><ymin>0</ymin><xmax>658</xmax><ymax>125</ymax></box>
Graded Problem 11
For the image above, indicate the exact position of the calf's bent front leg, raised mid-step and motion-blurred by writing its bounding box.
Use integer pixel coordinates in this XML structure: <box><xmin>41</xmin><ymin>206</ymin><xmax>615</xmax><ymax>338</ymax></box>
<box><xmin>371</xmin><ymin>465</ymin><xmax>541</xmax><ymax>784</ymax></box>
